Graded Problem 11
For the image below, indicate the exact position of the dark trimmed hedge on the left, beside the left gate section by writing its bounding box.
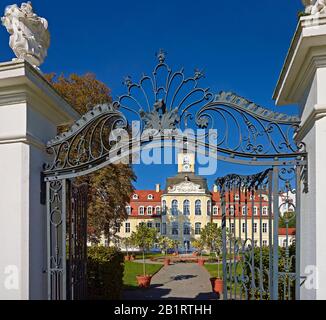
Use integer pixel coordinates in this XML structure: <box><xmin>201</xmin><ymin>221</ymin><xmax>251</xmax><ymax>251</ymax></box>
<box><xmin>87</xmin><ymin>246</ymin><xmax>124</xmax><ymax>300</ymax></box>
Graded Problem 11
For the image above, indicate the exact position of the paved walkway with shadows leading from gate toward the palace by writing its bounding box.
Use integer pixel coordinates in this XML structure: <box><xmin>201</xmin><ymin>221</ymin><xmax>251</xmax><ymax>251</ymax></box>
<box><xmin>123</xmin><ymin>263</ymin><xmax>217</xmax><ymax>300</ymax></box>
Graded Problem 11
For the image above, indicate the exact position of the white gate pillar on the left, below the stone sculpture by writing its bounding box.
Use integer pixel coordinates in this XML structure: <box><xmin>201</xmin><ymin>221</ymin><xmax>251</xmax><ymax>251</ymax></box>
<box><xmin>0</xmin><ymin>60</ymin><xmax>79</xmax><ymax>300</ymax></box>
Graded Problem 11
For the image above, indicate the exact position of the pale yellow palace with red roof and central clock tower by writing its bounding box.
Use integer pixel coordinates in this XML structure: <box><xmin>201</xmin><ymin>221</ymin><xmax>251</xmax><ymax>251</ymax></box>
<box><xmin>117</xmin><ymin>153</ymin><xmax>282</xmax><ymax>250</ymax></box>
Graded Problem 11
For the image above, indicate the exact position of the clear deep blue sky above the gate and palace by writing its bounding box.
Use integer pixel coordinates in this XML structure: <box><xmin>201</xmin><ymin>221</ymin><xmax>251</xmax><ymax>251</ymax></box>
<box><xmin>0</xmin><ymin>0</ymin><xmax>302</xmax><ymax>189</ymax></box>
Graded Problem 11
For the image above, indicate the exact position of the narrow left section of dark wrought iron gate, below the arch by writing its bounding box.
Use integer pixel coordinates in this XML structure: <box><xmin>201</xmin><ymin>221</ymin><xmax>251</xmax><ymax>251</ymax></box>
<box><xmin>46</xmin><ymin>179</ymin><xmax>88</xmax><ymax>300</ymax></box>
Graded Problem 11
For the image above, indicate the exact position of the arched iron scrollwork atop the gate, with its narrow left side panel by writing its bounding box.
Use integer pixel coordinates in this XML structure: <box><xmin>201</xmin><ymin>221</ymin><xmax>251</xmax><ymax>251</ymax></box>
<box><xmin>44</xmin><ymin>50</ymin><xmax>306</xmax><ymax>296</ymax></box>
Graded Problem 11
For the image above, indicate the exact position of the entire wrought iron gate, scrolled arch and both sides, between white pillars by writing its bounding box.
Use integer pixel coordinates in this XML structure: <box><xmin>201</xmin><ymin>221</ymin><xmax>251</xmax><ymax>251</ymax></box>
<box><xmin>43</xmin><ymin>51</ymin><xmax>307</xmax><ymax>300</ymax></box>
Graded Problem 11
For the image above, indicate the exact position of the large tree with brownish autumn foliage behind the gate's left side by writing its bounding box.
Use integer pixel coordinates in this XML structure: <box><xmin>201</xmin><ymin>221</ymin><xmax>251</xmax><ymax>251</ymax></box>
<box><xmin>46</xmin><ymin>73</ymin><xmax>136</xmax><ymax>243</ymax></box>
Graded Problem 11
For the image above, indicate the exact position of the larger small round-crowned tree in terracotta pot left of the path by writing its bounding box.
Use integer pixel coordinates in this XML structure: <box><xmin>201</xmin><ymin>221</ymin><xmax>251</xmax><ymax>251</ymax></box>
<box><xmin>131</xmin><ymin>224</ymin><xmax>157</xmax><ymax>276</ymax></box>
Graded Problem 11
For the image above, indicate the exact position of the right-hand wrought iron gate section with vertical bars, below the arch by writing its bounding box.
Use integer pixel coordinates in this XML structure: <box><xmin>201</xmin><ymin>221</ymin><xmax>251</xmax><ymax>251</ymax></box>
<box><xmin>216</xmin><ymin>164</ymin><xmax>303</xmax><ymax>300</ymax></box>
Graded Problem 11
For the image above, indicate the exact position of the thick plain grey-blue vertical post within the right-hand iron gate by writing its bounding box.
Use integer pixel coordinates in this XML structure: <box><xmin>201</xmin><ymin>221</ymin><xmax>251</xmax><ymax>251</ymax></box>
<box><xmin>272</xmin><ymin>166</ymin><xmax>279</xmax><ymax>300</ymax></box>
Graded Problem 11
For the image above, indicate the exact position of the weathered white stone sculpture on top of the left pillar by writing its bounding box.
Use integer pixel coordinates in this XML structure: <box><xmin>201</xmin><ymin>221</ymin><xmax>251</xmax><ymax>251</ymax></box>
<box><xmin>1</xmin><ymin>2</ymin><xmax>50</xmax><ymax>67</ymax></box>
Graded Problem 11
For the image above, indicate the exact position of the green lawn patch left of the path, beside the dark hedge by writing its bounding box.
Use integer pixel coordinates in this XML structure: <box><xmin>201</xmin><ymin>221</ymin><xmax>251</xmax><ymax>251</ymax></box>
<box><xmin>123</xmin><ymin>261</ymin><xmax>163</xmax><ymax>289</ymax></box>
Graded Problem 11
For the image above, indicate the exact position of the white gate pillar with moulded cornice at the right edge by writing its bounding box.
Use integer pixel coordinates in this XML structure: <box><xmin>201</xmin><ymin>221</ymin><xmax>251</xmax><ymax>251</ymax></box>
<box><xmin>274</xmin><ymin>14</ymin><xmax>326</xmax><ymax>299</ymax></box>
